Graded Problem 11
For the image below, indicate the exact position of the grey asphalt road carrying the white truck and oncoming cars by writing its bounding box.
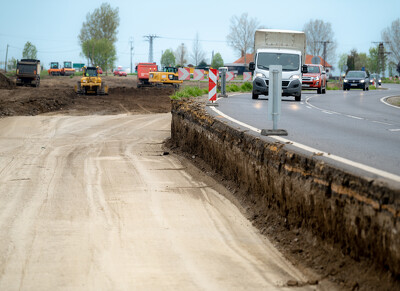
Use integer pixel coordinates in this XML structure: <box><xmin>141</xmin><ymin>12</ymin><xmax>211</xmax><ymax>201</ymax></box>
<box><xmin>208</xmin><ymin>84</ymin><xmax>400</xmax><ymax>183</ymax></box>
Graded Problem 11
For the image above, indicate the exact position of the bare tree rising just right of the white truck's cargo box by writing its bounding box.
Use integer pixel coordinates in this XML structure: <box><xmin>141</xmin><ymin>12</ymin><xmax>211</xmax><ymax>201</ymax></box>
<box><xmin>303</xmin><ymin>19</ymin><xmax>336</xmax><ymax>62</ymax></box>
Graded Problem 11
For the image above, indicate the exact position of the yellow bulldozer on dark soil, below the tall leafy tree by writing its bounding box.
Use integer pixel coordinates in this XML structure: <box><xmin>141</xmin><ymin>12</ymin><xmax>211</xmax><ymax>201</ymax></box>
<box><xmin>75</xmin><ymin>67</ymin><xmax>108</xmax><ymax>95</ymax></box>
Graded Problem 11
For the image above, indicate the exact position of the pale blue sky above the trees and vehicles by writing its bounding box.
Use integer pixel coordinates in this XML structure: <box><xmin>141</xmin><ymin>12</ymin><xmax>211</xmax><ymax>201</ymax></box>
<box><xmin>0</xmin><ymin>0</ymin><xmax>400</xmax><ymax>75</ymax></box>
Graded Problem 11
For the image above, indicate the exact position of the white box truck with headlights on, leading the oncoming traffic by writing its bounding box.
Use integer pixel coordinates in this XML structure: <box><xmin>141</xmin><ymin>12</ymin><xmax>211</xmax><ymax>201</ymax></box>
<box><xmin>249</xmin><ymin>29</ymin><xmax>307</xmax><ymax>101</ymax></box>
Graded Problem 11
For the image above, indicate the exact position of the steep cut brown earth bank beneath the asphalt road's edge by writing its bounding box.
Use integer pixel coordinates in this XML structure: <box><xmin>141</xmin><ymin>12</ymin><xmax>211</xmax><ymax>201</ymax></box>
<box><xmin>168</xmin><ymin>101</ymin><xmax>400</xmax><ymax>290</ymax></box>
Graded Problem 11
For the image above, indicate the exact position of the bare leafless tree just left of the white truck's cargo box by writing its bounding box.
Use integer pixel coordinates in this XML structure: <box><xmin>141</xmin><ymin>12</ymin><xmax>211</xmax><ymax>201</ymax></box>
<box><xmin>226</xmin><ymin>13</ymin><xmax>259</xmax><ymax>63</ymax></box>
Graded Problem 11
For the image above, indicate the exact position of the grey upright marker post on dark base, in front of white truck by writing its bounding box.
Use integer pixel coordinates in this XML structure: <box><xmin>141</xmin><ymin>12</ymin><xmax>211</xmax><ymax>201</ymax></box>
<box><xmin>261</xmin><ymin>66</ymin><xmax>288</xmax><ymax>135</ymax></box>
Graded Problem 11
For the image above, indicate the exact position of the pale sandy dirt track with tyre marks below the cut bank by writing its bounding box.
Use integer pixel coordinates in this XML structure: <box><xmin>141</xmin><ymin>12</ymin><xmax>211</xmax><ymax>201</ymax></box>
<box><xmin>0</xmin><ymin>113</ymin><xmax>324</xmax><ymax>290</ymax></box>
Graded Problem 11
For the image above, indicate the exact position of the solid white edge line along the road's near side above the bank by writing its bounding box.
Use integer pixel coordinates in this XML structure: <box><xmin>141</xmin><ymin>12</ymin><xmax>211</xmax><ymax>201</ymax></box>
<box><xmin>211</xmin><ymin>107</ymin><xmax>400</xmax><ymax>182</ymax></box>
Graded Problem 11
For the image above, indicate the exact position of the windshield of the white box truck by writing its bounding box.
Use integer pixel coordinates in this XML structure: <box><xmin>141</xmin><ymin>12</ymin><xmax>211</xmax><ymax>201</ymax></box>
<box><xmin>257</xmin><ymin>53</ymin><xmax>300</xmax><ymax>71</ymax></box>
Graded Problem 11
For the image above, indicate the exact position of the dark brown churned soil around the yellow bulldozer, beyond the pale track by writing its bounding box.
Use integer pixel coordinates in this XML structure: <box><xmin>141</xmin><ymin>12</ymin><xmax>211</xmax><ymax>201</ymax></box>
<box><xmin>0</xmin><ymin>76</ymin><xmax>174</xmax><ymax>116</ymax></box>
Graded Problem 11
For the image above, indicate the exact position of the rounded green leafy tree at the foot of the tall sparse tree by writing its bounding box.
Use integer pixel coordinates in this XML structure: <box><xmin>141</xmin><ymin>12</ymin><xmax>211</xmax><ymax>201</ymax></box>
<box><xmin>82</xmin><ymin>38</ymin><xmax>117</xmax><ymax>74</ymax></box>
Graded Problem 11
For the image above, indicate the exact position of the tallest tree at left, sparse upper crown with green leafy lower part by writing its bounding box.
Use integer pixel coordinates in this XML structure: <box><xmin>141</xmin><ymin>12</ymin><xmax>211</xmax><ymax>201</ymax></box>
<box><xmin>78</xmin><ymin>3</ymin><xmax>120</xmax><ymax>72</ymax></box>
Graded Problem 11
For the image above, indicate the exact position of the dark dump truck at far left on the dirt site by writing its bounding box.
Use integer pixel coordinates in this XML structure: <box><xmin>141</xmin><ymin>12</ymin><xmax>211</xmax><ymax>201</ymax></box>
<box><xmin>16</xmin><ymin>59</ymin><xmax>40</xmax><ymax>87</ymax></box>
